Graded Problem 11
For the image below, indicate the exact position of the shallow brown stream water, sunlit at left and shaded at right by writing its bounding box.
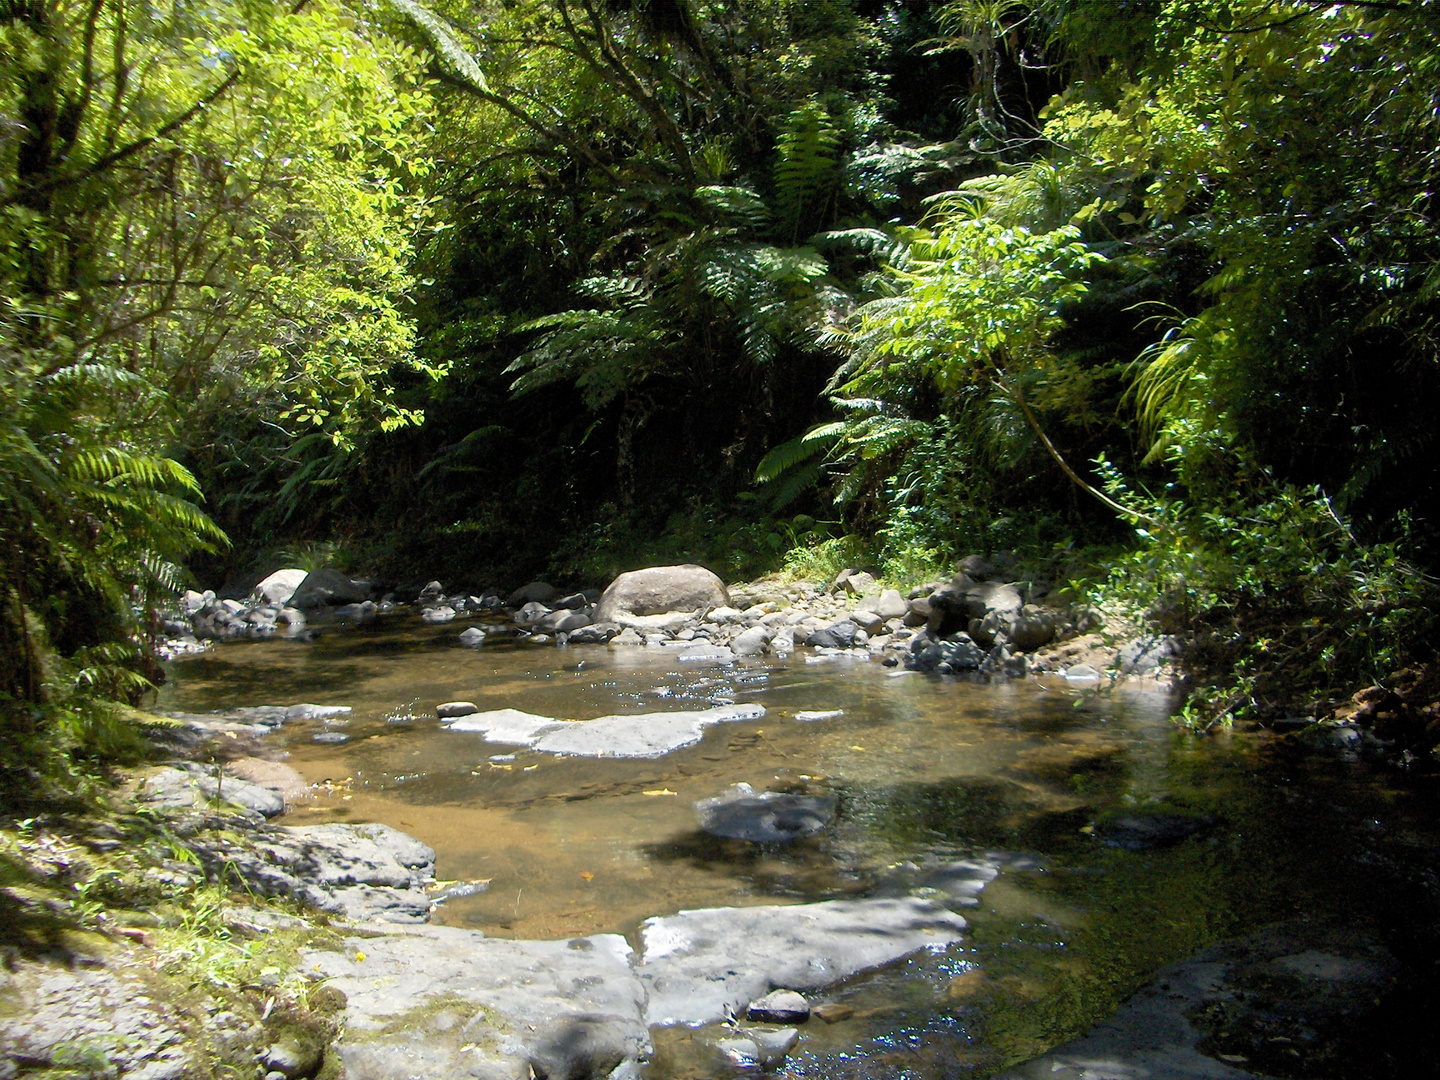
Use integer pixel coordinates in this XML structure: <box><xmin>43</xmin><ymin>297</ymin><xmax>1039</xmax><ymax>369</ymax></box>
<box><xmin>158</xmin><ymin>616</ymin><xmax>1440</xmax><ymax>1077</ymax></box>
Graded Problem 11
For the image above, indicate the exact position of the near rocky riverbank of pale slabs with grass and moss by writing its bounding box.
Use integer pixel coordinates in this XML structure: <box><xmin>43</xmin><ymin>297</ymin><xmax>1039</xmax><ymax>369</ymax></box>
<box><xmin>0</xmin><ymin>706</ymin><xmax>995</xmax><ymax>1080</ymax></box>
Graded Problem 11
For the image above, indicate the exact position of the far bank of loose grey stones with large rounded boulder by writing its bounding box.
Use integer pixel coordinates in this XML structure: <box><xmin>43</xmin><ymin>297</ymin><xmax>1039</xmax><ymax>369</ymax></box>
<box><xmin>163</xmin><ymin>556</ymin><xmax>1179</xmax><ymax>683</ymax></box>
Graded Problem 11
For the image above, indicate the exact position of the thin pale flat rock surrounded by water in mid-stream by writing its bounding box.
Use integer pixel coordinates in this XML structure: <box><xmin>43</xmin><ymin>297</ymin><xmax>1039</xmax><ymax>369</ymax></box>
<box><xmin>449</xmin><ymin>704</ymin><xmax>765</xmax><ymax>757</ymax></box>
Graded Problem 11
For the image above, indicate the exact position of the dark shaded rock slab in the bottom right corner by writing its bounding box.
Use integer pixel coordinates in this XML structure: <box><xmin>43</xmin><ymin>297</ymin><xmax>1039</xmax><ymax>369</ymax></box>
<box><xmin>1002</xmin><ymin>920</ymin><xmax>1395</xmax><ymax>1080</ymax></box>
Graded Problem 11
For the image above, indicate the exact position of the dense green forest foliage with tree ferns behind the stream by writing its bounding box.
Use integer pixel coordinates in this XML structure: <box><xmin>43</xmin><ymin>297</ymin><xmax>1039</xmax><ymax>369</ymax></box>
<box><xmin>0</xmin><ymin>0</ymin><xmax>1440</xmax><ymax>777</ymax></box>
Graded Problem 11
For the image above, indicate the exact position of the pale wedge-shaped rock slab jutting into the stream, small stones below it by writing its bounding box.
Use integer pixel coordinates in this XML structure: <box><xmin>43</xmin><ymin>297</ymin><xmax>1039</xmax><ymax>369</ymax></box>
<box><xmin>638</xmin><ymin>897</ymin><xmax>965</xmax><ymax>1025</ymax></box>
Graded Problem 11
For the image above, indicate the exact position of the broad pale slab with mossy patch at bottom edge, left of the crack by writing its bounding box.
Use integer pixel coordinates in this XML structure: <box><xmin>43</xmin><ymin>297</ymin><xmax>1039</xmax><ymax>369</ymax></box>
<box><xmin>302</xmin><ymin>926</ymin><xmax>651</xmax><ymax>1080</ymax></box>
